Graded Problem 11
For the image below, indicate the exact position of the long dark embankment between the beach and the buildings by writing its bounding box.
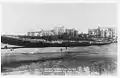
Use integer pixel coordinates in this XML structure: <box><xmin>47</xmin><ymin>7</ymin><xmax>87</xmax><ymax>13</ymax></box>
<box><xmin>1</xmin><ymin>36</ymin><xmax>113</xmax><ymax>49</ymax></box>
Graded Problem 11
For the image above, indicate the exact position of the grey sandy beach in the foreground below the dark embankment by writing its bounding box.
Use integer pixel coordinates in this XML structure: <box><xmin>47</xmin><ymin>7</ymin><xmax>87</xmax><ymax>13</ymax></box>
<box><xmin>1</xmin><ymin>43</ymin><xmax>117</xmax><ymax>74</ymax></box>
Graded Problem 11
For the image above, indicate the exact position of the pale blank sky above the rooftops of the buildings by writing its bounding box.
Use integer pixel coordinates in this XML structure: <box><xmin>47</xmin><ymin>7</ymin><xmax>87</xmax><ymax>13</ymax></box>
<box><xmin>2</xmin><ymin>3</ymin><xmax>117</xmax><ymax>34</ymax></box>
